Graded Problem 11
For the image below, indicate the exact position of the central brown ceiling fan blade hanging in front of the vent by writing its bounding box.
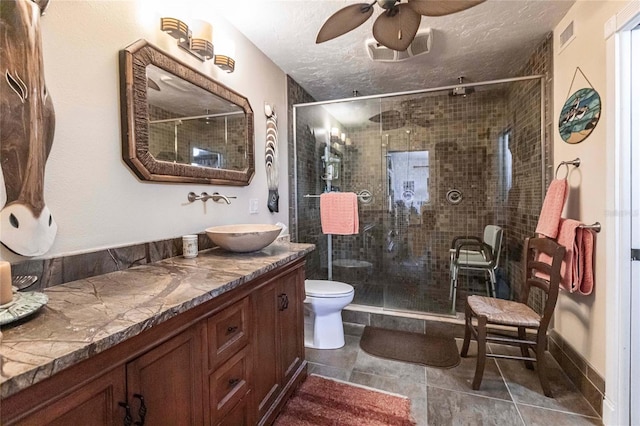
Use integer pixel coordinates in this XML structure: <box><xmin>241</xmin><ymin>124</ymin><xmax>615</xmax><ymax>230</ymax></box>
<box><xmin>373</xmin><ymin>3</ymin><xmax>422</xmax><ymax>51</ymax></box>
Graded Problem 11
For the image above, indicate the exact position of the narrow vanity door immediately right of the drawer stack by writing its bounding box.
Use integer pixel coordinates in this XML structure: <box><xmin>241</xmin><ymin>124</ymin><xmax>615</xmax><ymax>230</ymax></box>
<box><xmin>251</xmin><ymin>283</ymin><xmax>280</xmax><ymax>420</ymax></box>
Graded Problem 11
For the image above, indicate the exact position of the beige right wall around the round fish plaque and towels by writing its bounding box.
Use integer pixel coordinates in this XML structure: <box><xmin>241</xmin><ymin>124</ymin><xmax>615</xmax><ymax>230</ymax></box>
<box><xmin>553</xmin><ymin>0</ymin><xmax>627</xmax><ymax>376</ymax></box>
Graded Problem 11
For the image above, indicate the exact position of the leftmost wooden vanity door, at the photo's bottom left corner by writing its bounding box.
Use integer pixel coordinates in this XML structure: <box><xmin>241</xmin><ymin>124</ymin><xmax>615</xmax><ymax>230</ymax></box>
<box><xmin>7</xmin><ymin>367</ymin><xmax>125</xmax><ymax>426</ymax></box>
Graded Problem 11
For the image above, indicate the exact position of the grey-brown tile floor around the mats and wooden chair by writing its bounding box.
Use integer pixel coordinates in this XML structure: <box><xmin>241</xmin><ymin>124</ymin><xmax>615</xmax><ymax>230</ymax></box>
<box><xmin>306</xmin><ymin>323</ymin><xmax>602</xmax><ymax>426</ymax></box>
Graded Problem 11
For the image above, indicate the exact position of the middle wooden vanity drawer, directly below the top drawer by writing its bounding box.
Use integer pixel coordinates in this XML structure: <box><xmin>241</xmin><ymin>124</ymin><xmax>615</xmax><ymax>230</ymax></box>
<box><xmin>209</xmin><ymin>348</ymin><xmax>250</xmax><ymax>424</ymax></box>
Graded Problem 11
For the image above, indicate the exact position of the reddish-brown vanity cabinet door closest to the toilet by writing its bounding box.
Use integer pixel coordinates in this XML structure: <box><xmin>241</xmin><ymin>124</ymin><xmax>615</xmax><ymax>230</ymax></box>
<box><xmin>278</xmin><ymin>269</ymin><xmax>304</xmax><ymax>385</ymax></box>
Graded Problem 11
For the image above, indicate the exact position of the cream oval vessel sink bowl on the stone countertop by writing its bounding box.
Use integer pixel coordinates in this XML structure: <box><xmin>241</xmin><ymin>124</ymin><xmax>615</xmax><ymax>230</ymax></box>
<box><xmin>205</xmin><ymin>224</ymin><xmax>282</xmax><ymax>253</ymax></box>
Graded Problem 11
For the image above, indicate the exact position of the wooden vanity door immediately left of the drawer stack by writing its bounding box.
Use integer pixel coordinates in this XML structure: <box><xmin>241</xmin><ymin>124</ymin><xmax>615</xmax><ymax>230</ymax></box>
<box><xmin>126</xmin><ymin>324</ymin><xmax>203</xmax><ymax>426</ymax></box>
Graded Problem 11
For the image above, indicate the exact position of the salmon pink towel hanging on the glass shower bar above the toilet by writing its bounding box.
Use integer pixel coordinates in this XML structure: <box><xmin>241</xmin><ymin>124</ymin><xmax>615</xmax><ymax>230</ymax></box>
<box><xmin>320</xmin><ymin>192</ymin><xmax>360</xmax><ymax>235</ymax></box>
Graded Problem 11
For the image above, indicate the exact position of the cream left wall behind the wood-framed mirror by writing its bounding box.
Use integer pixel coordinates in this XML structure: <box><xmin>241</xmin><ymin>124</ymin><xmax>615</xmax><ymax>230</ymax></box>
<box><xmin>0</xmin><ymin>0</ymin><xmax>289</xmax><ymax>261</ymax></box>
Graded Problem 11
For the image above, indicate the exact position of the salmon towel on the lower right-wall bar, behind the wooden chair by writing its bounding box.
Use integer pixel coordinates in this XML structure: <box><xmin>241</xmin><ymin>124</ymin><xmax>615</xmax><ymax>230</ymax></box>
<box><xmin>539</xmin><ymin>219</ymin><xmax>594</xmax><ymax>295</ymax></box>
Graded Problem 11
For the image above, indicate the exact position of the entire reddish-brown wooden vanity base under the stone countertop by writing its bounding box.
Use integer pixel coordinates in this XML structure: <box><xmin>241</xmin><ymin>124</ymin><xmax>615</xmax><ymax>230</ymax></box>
<box><xmin>0</xmin><ymin>260</ymin><xmax>306</xmax><ymax>426</ymax></box>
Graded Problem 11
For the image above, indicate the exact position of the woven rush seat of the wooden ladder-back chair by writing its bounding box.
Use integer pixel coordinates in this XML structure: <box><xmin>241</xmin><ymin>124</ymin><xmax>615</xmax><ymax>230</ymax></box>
<box><xmin>467</xmin><ymin>296</ymin><xmax>540</xmax><ymax>327</ymax></box>
